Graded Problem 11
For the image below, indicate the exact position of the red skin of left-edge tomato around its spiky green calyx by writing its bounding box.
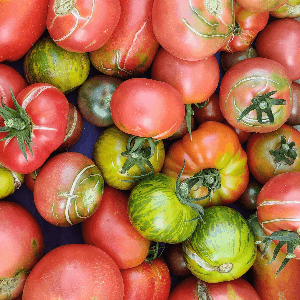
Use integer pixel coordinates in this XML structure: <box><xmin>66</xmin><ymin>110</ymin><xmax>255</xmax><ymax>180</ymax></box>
<box><xmin>0</xmin><ymin>83</ymin><xmax>69</xmax><ymax>174</ymax></box>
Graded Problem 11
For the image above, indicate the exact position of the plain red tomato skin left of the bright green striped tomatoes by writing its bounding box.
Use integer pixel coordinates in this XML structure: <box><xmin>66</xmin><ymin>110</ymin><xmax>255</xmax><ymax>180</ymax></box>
<box><xmin>81</xmin><ymin>185</ymin><xmax>150</xmax><ymax>269</ymax></box>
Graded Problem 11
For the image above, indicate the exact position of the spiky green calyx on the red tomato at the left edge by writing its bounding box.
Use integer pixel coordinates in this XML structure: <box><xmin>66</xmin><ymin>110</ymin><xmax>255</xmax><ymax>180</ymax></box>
<box><xmin>0</xmin><ymin>91</ymin><xmax>33</xmax><ymax>163</ymax></box>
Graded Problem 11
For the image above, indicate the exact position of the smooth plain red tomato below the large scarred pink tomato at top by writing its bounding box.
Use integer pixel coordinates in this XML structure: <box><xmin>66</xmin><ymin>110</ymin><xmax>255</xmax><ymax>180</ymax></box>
<box><xmin>151</xmin><ymin>48</ymin><xmax>220</xmax><ymax>104</ymax></box>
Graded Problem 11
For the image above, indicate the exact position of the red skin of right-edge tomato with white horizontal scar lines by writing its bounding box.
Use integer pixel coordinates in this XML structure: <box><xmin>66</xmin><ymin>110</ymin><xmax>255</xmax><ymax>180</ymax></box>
<box><xmin>257</xmin><ymin>172</ymin><xmax>300</xmax><ymax>256</ymax></box>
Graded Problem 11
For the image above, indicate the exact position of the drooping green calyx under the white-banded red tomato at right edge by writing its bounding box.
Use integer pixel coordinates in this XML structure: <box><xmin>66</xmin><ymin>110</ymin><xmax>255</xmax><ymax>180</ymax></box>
<box><xmin>255</xmin><ymin>230</ymin><xmax>300</xmax><ymax>276</ymax></box>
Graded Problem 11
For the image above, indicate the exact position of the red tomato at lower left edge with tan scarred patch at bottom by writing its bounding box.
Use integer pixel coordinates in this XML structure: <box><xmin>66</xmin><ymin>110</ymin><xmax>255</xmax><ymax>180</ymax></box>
<box><xmin>0</xmin><ymin>201</ymin><xmax>44</xmax><ymax>299</ymax></box>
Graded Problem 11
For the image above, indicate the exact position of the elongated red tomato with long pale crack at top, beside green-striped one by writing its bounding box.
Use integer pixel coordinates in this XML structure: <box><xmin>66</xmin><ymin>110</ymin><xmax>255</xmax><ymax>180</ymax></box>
<box><xmin>90</xmin><ymin>0</ymin><xmax>159</xmax><ymax>78</ymax></box>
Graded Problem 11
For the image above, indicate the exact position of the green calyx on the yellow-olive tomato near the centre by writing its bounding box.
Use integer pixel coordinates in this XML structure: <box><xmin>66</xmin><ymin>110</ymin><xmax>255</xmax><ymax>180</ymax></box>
<box><xmin>120</xmin><ymin>135</ymin><xmax>159</xmax><ymax>182</ymax></box>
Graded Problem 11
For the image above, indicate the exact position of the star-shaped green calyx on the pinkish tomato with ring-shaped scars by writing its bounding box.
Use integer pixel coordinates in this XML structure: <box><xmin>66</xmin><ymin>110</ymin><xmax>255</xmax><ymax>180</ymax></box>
<box><xmin>237</xmin><ymin>91</ymin><xmax>286</xmax><ymax>124</ymax></box>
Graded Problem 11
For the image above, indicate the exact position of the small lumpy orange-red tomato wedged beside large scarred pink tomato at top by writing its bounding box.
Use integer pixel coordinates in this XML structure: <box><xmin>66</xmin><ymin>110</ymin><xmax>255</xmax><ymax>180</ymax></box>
<box><xmin>220</xmin><ymin>1</ymin><xmax>269</xmax><ymax>52</ymax></box>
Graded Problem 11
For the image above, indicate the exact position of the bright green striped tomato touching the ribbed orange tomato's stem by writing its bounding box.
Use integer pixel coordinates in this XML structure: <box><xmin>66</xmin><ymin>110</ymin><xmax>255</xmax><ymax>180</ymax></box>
<box><xmin>128</xmin><ymin>173</ymin><xmax>197</xmax><ymax>244</ymax></box>
